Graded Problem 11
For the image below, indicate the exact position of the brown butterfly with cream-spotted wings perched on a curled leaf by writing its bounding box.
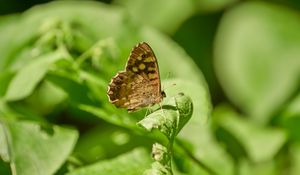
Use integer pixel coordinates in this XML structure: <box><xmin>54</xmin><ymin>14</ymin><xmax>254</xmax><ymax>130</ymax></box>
<box><xmin>107</xmin><ymin>42</ymin><xmax>166</xmax><ymax>112</ymax></box>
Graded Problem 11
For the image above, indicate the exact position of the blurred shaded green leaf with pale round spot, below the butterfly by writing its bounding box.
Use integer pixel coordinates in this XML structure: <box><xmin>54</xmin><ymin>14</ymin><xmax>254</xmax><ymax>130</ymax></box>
<box><xmin>73</xmin><ymin>124</ymin><xmax>153</xmax><ymax>164</ymax></box>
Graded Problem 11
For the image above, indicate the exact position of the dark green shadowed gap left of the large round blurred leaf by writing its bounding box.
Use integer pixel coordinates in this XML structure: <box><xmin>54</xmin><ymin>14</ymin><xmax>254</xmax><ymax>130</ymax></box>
<box><xmin>172</xmin><ymin>13</ymin><xmax>224</xmax><ymax>102</ymax></box>
